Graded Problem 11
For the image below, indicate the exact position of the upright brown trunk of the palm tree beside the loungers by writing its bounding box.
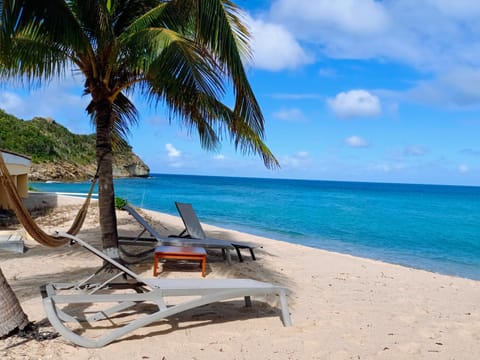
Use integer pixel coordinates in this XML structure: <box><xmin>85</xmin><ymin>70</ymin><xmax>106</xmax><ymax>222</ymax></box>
<box><xmin>96</xmin><ymin>100</ymin><xmax>118</xmax><ymax>253</ymax></box>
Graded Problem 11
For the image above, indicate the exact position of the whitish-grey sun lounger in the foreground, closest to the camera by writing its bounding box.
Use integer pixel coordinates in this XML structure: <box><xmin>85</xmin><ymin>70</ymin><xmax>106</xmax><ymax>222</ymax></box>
<box><xmin>41</xmin><ymin>233</ymin><xmax>291</xmax><ymax>348</ymax></box>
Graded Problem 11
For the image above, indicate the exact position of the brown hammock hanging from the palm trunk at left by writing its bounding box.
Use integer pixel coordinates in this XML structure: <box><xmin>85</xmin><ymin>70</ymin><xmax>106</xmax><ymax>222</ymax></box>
<box><xmin>0</xmin><ymin>152</ymin><xmax>98</xmax><ymax>247</ymax></box>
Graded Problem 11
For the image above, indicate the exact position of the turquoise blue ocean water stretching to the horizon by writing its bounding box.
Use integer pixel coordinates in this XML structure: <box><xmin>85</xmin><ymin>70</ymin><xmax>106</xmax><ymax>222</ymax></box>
<box><xmin>31</xmin><ymin>174</ymin><xmax>480</xmax><ymax>280</ymax></box>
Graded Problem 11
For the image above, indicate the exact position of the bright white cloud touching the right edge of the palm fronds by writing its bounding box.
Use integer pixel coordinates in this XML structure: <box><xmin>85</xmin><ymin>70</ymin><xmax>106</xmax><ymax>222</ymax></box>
<box><xmin>249</xmin><ymin>18</ymin><xmax>313</xmax><ymax>71</ymax></box>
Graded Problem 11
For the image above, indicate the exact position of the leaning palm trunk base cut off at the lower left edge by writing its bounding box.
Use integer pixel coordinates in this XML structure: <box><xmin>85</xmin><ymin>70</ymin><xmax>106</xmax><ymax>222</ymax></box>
<box><xmin>0</xmin><ymin>269</ymin><xmax>29</xmax><ymax>337</ymax></box>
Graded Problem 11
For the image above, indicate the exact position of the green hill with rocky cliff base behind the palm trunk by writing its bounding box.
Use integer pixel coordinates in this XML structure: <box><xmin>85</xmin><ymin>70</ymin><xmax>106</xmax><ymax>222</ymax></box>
<box><xmin>0</xmin><ymin>110</ymin><xmax>150</xmax><ymax>181</ymax></box>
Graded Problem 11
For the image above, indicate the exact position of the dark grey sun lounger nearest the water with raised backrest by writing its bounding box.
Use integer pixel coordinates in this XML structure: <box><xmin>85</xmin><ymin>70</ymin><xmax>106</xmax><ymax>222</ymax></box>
<box><xmin>175</xmin><ymin>202</ymin><xmax>256</xmax><ymax>262</ymax></box>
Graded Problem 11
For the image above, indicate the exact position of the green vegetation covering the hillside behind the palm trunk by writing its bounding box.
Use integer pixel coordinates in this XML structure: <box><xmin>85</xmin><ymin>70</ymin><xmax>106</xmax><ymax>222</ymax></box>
<box><xmin>0</xmin><ymin>110</ymin><xmax>131</xmax><ymax>165</ymax></box>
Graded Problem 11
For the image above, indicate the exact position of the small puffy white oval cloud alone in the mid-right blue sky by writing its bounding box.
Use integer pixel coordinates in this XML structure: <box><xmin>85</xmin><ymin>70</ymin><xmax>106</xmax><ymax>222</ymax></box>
<box><xmin>327</xmin><ymin>90</ymin><xmax>381</xmax><ymax>118</ymax></box>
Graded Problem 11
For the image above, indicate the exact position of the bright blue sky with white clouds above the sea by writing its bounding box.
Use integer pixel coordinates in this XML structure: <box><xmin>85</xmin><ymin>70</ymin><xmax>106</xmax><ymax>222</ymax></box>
<box><xmin>0</xmin><ymin>0</ymin><xmax>480</xmax><ymax>185</ymax></box>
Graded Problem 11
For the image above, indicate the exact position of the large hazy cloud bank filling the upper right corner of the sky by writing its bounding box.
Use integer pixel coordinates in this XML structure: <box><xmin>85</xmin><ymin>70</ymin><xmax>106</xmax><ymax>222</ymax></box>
<box><xmin>265</xmin><ymin>0</ymin><xmax>480</xmax><ymax>107</ymax></box>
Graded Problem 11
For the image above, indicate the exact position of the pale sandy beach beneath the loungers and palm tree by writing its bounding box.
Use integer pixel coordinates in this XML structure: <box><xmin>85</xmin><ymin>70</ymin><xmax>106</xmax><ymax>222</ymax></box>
<box><xmin>0</xmin><ymin>197</ymin><xmax>480</xmax><ymax>360</ymax></box>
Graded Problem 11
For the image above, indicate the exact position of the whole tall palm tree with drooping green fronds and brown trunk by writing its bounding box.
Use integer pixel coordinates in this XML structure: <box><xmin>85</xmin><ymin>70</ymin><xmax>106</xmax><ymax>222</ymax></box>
<box><xmin>0</xmin><ymin>0</ymin><xmax>278</xmax><ymax>256</ymax></box>
